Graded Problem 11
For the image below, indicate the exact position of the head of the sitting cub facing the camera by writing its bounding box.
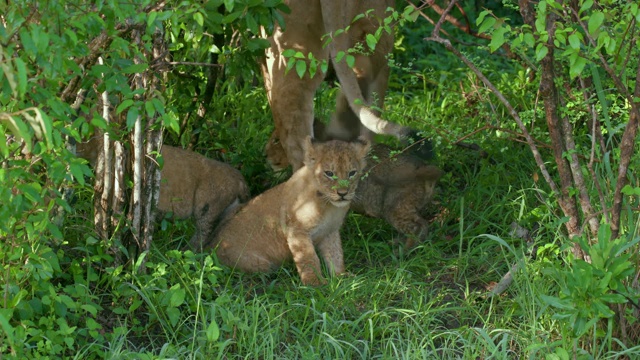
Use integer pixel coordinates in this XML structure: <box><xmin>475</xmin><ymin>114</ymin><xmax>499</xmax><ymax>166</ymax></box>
<box><xmin>305</xmin><ymin>138</ymin><xmax>369</xmax><ymax>207</ymax></box>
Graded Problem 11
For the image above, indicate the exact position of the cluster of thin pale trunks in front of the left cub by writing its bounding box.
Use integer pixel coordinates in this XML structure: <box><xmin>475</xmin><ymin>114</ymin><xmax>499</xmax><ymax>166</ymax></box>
<box><xmin>67</xmin><ymin>3</ymin><xmax>167</xmax><ymax>263</ymax></box>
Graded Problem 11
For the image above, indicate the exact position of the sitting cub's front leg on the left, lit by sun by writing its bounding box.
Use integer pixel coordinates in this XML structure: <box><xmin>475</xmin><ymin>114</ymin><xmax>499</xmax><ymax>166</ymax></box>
<box><xmin>287</xmin><ymin>229</ymin><xmax>326</xmax><ymax>286</ymax></box>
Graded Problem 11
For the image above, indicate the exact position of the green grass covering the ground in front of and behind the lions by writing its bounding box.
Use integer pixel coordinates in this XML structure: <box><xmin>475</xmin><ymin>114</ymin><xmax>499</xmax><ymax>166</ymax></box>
<box><xmin>5</xmin><ymin>61</ymin><xmax>640</xmax><ymax>359</ymax></box>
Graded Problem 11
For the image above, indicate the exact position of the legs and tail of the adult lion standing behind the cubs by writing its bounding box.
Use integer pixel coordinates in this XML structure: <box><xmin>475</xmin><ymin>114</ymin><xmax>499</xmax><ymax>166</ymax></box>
<box><xmin>261</xmin><ymin>0</ymin><xmax>410</xmax><ymax>171</ymax></box>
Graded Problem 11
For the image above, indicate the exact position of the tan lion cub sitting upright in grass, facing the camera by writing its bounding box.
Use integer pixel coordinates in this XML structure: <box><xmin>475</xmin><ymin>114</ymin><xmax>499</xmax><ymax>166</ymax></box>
<box><xmin>209</xmin><ymin>137</ymin><xmax>369</xmax><ymax>285</ymax></box>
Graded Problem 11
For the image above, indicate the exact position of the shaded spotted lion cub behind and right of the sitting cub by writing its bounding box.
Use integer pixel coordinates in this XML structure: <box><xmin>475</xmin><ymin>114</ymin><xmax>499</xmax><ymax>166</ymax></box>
<box><xmin>266</xmin><ymin>134</ymin><xmax>442</xmax><ymax>248</ymax></box>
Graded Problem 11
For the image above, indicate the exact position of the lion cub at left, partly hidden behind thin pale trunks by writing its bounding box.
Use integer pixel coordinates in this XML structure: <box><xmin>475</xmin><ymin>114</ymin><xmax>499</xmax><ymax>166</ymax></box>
<box><xmin>77</xmin><ymin>136</ymin><xmax>249</xmax><ymax>250</ymax></box>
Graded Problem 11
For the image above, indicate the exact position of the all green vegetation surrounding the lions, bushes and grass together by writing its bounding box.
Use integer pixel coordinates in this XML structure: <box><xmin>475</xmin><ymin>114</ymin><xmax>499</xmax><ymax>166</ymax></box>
<box><xmin>0</xmin><ymin>0</ymin><xmax>640</xmax><ymax>359</ymax></box>
